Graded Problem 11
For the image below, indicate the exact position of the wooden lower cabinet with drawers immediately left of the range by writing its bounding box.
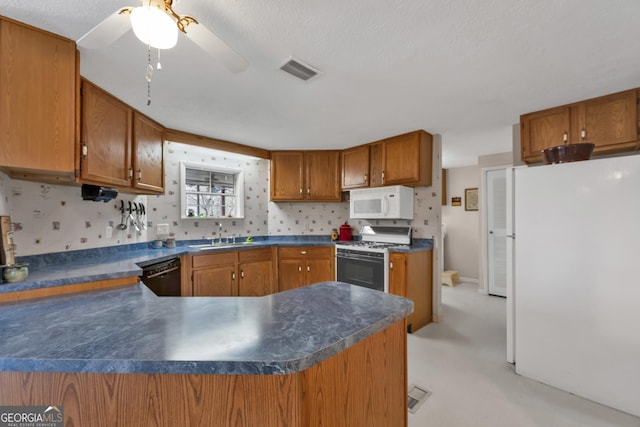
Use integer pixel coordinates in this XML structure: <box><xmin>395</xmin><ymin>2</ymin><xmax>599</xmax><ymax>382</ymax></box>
<box><xmin>278</xmin><ymin>246</ymin><xmax>335</xmax><ymax>292</ymax></box>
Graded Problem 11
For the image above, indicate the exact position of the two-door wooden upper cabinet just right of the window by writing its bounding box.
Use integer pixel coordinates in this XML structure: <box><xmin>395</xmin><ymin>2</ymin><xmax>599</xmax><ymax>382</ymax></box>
<box><xmin>271</xmin><ymin>150</ymin><xmax>340</xmax><ymax>202</ymax></box>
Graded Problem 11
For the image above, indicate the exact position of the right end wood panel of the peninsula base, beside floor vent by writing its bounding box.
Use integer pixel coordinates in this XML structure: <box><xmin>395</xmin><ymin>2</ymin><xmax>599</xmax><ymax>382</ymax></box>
<box><xmin>301</xmin><ymin>321</ymin><xmax>407</xmax><ymax>427</ymax></box>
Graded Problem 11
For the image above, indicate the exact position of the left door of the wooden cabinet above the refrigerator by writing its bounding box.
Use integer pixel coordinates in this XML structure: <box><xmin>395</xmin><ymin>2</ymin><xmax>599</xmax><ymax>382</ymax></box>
<box><xmin>520</xmin><ymin>107</ymin><xmax>571</xmax><ymax>163</ymax></box>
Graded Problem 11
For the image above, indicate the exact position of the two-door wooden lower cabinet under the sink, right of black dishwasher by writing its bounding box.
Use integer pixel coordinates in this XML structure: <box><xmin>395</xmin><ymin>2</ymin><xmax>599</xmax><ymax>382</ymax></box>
<box><xmin>185</xmin><ymin>248</ymin><xmax>276</xmax><ymax>297</ymax></box>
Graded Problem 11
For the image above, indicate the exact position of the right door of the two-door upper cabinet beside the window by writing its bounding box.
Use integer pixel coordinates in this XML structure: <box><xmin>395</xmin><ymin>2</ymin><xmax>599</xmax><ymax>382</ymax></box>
<box><xmin>305</xmin><ymin>150</ymin><xmax>340</xmax><ymax>202</ymax></box>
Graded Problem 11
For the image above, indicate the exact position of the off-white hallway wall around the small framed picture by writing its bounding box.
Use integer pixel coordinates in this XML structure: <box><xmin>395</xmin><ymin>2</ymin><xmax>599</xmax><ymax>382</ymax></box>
<box><xmin>442</xmin><ymin>166</ymin><xmax>480</xmax><ymax>280</ymax></box>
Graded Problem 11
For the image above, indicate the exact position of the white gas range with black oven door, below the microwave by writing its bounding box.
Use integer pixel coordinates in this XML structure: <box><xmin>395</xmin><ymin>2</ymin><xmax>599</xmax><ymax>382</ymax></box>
<box><xmin>336</xmin><ymin>225</ymin><xmax>411</xmax><ymax>292</ymax></box>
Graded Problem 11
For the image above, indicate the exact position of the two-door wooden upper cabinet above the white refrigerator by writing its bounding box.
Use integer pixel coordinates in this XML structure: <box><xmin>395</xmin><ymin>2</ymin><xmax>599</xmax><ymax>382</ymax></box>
<box><xmin>520</xmin><ymin>89</ymin><xmax>640</xmax><ymax>163</ymax></box>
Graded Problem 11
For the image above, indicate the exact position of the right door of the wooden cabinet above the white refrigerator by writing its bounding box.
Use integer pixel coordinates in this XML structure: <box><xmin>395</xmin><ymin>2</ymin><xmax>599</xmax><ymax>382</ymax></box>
<box><xmin>571</xmin><ymin>90</ymin><xmax>638</xmax><ymax>150</ymax></box>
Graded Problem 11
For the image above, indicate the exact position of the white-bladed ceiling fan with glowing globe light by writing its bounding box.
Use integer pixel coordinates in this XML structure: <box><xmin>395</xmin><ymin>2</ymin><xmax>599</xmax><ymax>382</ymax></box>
<box><xmin>77</xmin><ymin>0</ymin><xmax>249</xmax><ymax>73</ymax></box>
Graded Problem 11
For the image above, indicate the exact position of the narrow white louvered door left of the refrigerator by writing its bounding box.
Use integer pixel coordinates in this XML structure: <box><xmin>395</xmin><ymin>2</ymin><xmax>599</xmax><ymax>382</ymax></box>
<box><xmin>485</xmin><ymin>169</ymin><xmax>507</xmax><ymax>297</ymax></box>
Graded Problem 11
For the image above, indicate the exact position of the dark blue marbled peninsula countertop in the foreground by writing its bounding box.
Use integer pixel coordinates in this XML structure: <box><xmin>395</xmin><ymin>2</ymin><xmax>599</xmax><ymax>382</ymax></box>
<box><xmin>0</xmin><ymin>282</ymin><xmax>413</xmax><ymax>374</ymax></box>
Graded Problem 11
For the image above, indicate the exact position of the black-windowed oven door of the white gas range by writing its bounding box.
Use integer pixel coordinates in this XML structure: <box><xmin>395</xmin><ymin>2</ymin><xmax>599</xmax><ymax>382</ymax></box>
<box><xmin>336</xmin><ymin>249</ymin><xmax>389</xmax><ymax>292</ymax></box>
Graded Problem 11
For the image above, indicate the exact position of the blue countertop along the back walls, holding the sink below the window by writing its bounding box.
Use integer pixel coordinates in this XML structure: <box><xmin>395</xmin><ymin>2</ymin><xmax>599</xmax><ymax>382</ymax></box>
<box><xmin>0</xmin><ymin>236</ymin><xmax>431</xmax><ymax>294</ymax></box>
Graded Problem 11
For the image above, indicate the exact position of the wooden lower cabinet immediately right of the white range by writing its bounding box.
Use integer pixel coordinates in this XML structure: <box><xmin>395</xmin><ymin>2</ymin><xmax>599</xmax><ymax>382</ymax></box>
<box><xmin>389</xmin><ymin>251</ymin><xmax>433</xmax><ymax>332</ymax></box>
